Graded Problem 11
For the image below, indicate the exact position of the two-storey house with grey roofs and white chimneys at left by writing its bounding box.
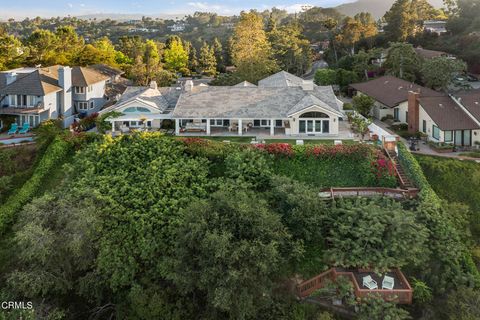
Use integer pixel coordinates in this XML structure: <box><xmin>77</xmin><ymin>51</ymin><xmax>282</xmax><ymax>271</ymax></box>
<box><xmin>0</xmin><ymin>65</ymin><xmax>121</xmax><ymax>127</ymax></box>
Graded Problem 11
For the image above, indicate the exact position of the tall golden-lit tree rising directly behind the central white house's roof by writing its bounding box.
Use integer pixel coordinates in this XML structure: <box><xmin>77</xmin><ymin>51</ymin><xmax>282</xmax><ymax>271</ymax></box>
<box><xmin>232</xmin><ymin>11</ymin><xmax>278</xmax><ymax>83</ymax></box>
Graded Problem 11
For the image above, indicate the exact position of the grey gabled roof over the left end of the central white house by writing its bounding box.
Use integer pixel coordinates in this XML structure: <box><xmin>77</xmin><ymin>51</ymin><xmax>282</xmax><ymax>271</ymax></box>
<box><xmin>100</xmin><ymin>87</ymin><xmax>168</xmax><ymax>113</ymax></box>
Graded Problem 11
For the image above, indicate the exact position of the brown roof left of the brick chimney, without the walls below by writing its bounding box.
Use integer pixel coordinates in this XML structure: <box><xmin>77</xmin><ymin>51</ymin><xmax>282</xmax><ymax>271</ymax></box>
<box><xmin>351</xmin><ymin>76</ymin><xmax>443</xmax><ymax>108</ymax></box>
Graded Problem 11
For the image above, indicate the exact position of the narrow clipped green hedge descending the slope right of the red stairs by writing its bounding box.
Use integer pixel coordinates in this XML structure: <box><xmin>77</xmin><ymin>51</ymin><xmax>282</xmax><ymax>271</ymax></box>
<box><xmin>398</xmin><ymin>142</ymin><xmax>440</xmax><ymax>206</ymax></box>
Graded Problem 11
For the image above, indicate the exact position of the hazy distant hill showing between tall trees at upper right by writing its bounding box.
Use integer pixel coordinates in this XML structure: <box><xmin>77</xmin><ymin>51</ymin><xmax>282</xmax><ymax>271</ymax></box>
<box><xmin>335</xmin><ymin>0</ymin><xmax>443</xmax><ymax>19</ymax></box>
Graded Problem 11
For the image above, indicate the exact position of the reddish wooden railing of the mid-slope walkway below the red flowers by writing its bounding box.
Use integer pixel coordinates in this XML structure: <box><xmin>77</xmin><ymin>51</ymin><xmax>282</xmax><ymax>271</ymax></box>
<box><xmin>321</xmin><ymin>187</ymin><xmax>418</xmax><ymax>199</ymax></box>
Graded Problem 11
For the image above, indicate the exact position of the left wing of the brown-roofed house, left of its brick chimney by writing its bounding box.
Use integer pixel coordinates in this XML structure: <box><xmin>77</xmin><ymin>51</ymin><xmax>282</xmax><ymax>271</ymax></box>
<box><xmin>351</xmin><ymin>76</ymin><xmax>442</xmax><ymax>123</ymax></box>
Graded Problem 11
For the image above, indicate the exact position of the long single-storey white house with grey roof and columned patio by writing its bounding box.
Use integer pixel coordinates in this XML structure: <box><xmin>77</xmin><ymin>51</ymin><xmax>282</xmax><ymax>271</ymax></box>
<box><xmin>101</xmin><ymin>71</ymin><xmax>344</xmax><ymax>136</ymax></box>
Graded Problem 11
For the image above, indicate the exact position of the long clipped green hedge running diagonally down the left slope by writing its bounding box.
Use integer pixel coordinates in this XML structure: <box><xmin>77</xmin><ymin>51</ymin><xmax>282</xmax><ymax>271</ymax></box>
<box><xmin>0</xmin><ymin>137</ymin><xmax>72</xmax><ymax>234</ymax></box>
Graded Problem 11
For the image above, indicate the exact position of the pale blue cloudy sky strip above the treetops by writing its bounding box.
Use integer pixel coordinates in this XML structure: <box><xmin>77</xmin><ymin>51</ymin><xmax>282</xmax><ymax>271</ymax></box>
<box><xmin>0</xmin><ymin>0</ymin><xmax>354</xmax><ymax>18</ymax></box>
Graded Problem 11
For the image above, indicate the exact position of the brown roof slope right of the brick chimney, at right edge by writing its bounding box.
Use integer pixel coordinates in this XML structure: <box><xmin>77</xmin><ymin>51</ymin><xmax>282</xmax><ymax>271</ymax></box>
<box><xmin>419</xmin><ymin>95</ymin><xmax>480</xmax><ymax>131</ymax></box>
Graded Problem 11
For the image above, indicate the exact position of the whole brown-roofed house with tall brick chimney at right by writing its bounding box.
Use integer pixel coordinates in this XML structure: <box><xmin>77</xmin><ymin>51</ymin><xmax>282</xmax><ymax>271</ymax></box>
<box><xmin>352</xmin><ymin>76</ymin><xmax>480</xmax><ymax>146</ymax></box>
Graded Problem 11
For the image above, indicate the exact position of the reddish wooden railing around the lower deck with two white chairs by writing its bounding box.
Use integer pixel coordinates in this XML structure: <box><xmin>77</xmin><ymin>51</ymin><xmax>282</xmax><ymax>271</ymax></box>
<box><xmin>297</xmin><ymin>268</ymin><xmax>413</xmax><ymax>304</ymax></box>
